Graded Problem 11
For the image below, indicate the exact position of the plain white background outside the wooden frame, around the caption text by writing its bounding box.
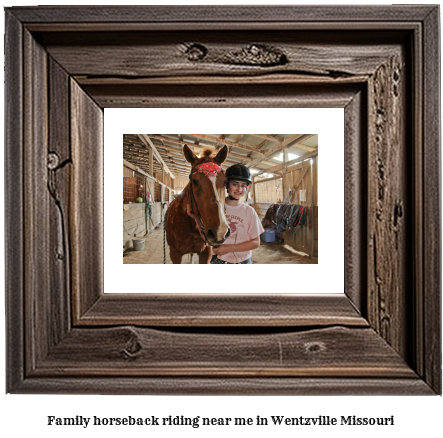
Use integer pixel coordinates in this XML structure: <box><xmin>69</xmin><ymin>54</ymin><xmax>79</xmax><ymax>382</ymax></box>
<box><xmin>0</xmin><ymin>0</ymin><xmax>443</xmax><ymax>438</ymax></box>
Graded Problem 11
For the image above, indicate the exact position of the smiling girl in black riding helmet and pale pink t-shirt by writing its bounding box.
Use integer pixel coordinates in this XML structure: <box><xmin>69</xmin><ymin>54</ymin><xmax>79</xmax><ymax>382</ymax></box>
<box><xmin>211</xmin><ymin>164</ymin><xmax>264</xmax><ymax>264</ymax></box>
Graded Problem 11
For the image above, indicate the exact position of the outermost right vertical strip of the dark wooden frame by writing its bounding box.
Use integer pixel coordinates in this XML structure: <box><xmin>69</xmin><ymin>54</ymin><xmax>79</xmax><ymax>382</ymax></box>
<box><xmin>420</xmin><ymin>8</ymin><xmax>442</xmax><ymax>393</ymax></box>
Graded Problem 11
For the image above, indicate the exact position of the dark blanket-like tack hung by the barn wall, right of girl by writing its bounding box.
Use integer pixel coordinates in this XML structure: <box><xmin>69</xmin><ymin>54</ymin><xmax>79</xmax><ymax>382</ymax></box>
<box><xmin>262</xmin><ymin>204</ymin><xmax>307</xmax><ymax>233</ymax></box>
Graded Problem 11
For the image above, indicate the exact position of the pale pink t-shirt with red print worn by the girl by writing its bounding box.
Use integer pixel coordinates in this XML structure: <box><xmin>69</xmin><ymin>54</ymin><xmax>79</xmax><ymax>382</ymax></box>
<box><xmin>218</xmin><ymin>203</ymin><xmax>264</xmax><ymax>263</ymax></box>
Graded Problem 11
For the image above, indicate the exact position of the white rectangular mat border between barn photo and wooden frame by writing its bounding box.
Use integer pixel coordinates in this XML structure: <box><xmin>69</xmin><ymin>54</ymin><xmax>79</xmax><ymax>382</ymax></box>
<box><xmin>104</xmin><ymin>108</ymin><xmax>344</xmax><ymax>293</ymax></box>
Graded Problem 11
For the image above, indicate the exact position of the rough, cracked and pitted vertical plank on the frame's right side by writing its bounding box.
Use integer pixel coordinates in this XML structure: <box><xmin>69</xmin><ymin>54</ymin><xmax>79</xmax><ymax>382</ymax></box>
<box><xmin>367</xmin><ymin>53</ymin><xmax>412</xmax><ymax>355</ymax></box>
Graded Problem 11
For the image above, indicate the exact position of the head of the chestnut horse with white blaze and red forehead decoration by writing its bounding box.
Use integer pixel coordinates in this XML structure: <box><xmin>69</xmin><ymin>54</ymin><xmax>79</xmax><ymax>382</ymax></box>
<box><xmin>183</xmin><ymin>144</ymin><xmax>231</xmax><ymax>246</ymax></box>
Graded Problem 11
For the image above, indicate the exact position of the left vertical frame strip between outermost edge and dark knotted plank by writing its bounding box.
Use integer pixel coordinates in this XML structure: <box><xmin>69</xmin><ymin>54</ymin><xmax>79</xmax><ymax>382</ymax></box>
<box><xmin>23</xmin><ymin>32</ymin><xmax>50</xmax><ymax>371</ymax></box>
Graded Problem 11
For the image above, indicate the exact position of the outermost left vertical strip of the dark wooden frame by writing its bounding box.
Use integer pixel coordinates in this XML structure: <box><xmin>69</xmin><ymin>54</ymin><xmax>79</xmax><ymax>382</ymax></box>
<box><xmin>5</xmin><ymin>11</ymin><xmax>25</xmax><ymax>389</ymax></box>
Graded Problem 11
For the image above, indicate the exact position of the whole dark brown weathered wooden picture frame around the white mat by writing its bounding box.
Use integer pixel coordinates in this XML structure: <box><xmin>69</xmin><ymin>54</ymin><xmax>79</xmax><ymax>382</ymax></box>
<box><xmin>5</xmin><ymin>6</ymin><xmax>441</xmax><ymax>394</ymax></box>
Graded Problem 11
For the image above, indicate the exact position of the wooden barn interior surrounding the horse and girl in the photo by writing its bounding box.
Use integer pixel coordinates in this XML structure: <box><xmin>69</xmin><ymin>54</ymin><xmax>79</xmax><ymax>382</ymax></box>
<box><xmin>123</xmin><ymin>134</ymin><xmax>318</xmax><ymax>264</ymax></box>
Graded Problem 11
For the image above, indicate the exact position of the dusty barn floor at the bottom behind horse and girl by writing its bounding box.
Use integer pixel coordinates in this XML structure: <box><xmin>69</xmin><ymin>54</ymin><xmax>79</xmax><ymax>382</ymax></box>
<box><xmin>123</xmin><ymin>225</ymin><xmax>318</xmax><ymax>265</ymax></box>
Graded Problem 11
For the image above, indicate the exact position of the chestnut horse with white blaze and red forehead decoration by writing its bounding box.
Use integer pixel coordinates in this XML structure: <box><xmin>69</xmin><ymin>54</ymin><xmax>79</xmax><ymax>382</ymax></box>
<box><xmin>165</xmin><ymin>144</ymin><xmax>231</xmax><ymax>264</ymax></box>
